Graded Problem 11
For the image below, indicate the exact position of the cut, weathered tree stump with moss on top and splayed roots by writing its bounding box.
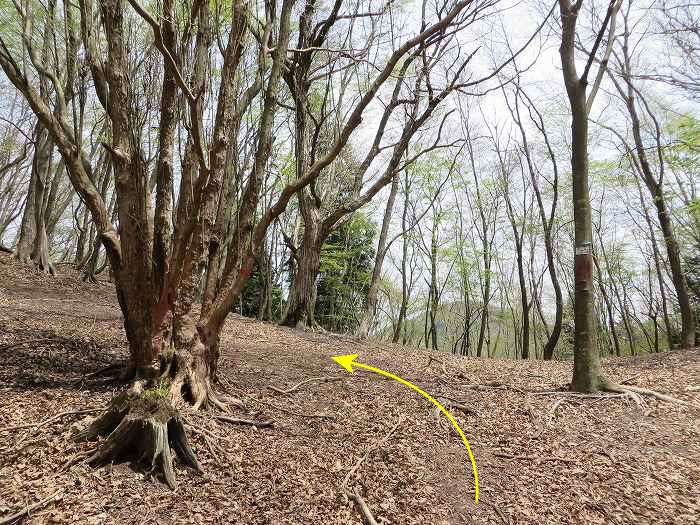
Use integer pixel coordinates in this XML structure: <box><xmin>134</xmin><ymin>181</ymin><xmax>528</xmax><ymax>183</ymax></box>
<box><xmin>75</xmin><ymin>390</ymin><xmax>201</xmax><ymax>489</ymax></box>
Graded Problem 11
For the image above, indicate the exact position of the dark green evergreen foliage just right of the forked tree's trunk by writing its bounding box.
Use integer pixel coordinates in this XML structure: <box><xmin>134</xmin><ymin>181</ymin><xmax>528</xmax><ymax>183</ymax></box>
<box><xmin>315</xmin><ymin>214</ymin><xmax>376</xmax><ymax>332</ymax></box>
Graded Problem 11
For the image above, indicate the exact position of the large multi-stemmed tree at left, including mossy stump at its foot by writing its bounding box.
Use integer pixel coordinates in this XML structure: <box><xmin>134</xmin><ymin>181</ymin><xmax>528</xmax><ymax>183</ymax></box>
<box><xmin>0</xmin><ymin>0</ymin><xmax>471</xmax><ymax>486</ymax></box>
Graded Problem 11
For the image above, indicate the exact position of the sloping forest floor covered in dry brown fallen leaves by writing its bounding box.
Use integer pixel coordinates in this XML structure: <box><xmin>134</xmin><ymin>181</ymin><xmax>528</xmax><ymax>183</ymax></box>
<box><xmin>0</xmin><ymin>254</ymin><xmax>700</xmax><ymax>524</ymax></box>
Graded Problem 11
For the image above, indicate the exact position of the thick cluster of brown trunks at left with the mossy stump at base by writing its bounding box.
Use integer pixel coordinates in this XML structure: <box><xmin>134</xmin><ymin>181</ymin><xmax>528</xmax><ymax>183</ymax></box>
<box><xmin>0</xmin><ymin>0</ymin><xmax>469</xmax><ymax>492</ymax></box>
